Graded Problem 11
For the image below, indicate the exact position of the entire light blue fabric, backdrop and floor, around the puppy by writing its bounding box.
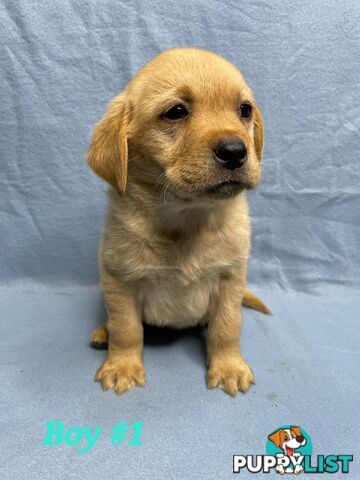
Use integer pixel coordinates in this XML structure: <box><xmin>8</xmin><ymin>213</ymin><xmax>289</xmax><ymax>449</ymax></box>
<box><xmin>0</xmin><ymin>0</ymin><xmax>360</xmax><ymax>479</ymax></box>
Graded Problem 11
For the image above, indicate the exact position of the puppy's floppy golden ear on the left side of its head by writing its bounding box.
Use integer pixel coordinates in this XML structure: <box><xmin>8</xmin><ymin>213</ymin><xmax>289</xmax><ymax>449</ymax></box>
<box><xmin>87</xmin><ymin>93</ymin><xmax>129</xmax><ymax>194</ymax></box>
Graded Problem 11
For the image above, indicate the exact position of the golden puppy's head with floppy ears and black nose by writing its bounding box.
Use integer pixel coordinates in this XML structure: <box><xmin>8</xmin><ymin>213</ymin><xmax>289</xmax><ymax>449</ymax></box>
<box><xmin>88</xmin><ymin>48</ymin><xmax>264</xmax><ymax>200</ymax></box>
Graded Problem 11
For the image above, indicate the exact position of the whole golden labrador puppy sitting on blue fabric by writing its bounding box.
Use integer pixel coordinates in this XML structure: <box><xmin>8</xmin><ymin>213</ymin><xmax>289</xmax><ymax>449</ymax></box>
<box><xmin>88</xmin><ymin>48</ymin><xmax>268</xmax><ymax>395</ymax></box>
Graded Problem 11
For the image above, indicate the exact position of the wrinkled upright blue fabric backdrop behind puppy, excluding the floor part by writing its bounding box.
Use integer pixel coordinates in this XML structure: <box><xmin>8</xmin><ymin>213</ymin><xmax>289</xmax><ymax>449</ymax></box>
<box><xmin>0</xmin><ymin>0</ymin><xmax>360</xmax><ymax>291</ymax></box>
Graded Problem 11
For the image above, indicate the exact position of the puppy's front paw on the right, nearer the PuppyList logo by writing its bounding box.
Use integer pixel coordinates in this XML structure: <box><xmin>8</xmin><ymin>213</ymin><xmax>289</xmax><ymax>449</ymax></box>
<box><xmin>207</xmin><ymin>356</ymin><xmax>255</xmax><ymax>397</ymax></box>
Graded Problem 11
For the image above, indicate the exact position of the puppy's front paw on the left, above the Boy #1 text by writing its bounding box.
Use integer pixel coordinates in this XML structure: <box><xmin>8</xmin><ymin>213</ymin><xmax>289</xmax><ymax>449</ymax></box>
<box><xmin>95</xmin><ymin>357</ymin><xmax>145</xmax><ymax>395</ymax></box>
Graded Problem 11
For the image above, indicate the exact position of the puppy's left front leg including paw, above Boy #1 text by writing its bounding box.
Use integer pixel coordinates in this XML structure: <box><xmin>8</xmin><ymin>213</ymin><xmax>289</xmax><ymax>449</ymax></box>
<box><xmin>96</xmin><ymin>275</ymin><xmax>145</xmax><ymax>395</ymax></box>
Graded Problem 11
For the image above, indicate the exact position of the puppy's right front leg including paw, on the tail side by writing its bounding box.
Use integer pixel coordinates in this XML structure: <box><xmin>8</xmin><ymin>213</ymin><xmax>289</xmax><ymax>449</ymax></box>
<box><xmin>207</xmin><ymin>279</ymin><xmax>255</xmax><ymax>396</ymax></box>
